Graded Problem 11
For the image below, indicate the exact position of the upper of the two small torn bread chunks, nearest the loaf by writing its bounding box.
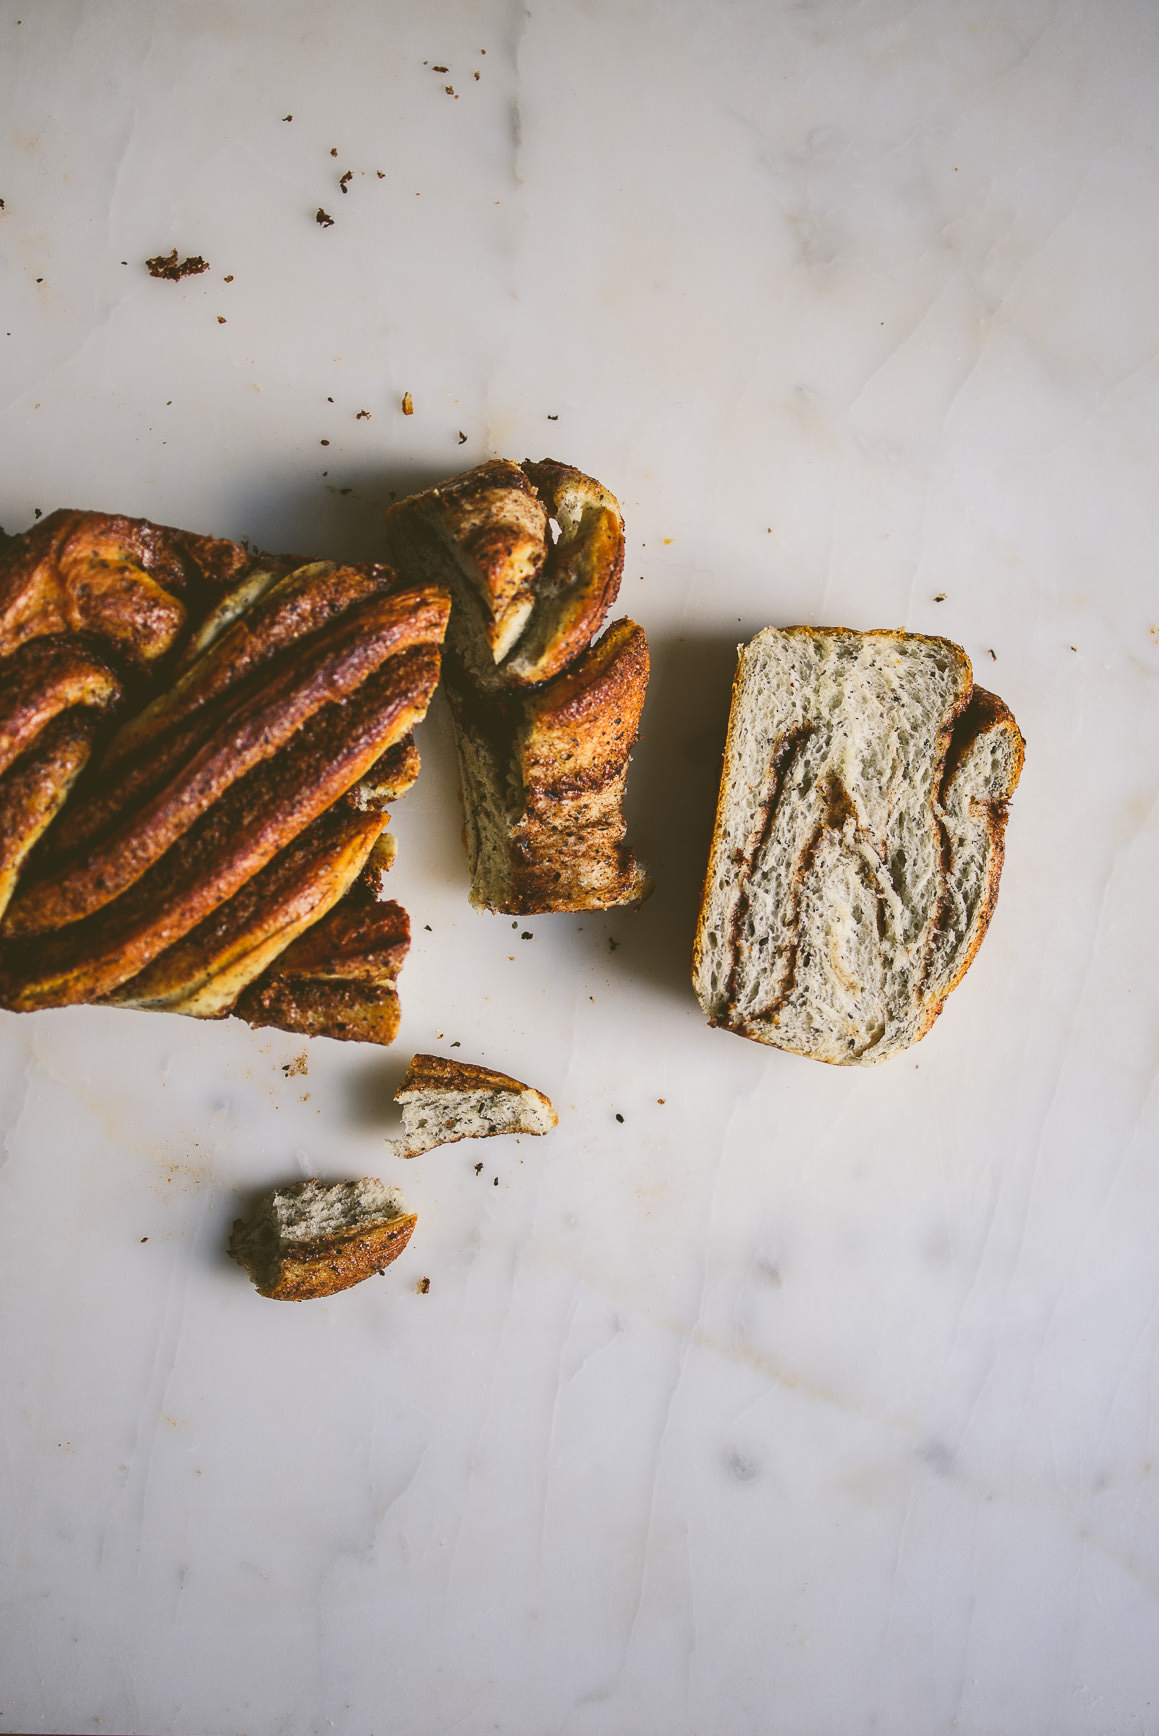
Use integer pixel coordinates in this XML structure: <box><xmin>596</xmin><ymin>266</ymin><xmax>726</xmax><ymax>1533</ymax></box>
<box><xmin>389</xmin><ymin>1055</ymin><xmax>559</xmax><ymax>1158</ymax></box>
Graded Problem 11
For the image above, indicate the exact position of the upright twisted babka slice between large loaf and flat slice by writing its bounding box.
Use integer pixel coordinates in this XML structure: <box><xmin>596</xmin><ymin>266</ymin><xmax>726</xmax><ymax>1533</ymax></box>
<box><xmin>387</xmin><ymin>458</ymin><xmax>649</xmax><ymax>915</ymax></box>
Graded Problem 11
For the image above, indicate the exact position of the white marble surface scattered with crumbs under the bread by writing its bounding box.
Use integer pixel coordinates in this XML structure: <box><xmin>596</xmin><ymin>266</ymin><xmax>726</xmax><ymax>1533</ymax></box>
<box><xmin>0</xmin><ymin>0</ymin><xmax>1159</xmax><ymax>1736</ymax></box>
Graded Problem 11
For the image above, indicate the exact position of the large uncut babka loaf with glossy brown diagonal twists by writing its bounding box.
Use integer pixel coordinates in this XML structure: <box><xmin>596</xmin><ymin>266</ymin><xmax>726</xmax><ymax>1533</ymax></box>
<box><xmin>0</xmin><ymin>512</ymin><xmax>449</xmax><ymax>1042</ymax></box>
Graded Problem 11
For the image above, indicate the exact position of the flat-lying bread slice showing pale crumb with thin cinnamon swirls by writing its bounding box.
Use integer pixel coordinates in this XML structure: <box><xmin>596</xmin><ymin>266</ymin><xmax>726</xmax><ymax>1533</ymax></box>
<box><xmin>692</xmin><ymin>627</ymin><xmax>1024</xmax><ymax>1066</ymax></box>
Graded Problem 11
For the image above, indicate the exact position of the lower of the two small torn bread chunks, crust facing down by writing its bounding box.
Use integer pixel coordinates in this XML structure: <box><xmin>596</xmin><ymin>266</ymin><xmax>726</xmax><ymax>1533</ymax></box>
<box><xmin>229</xmin><ymin>1175</ymin><xmax>416</xmax><ymax>1302</ymax></box>
